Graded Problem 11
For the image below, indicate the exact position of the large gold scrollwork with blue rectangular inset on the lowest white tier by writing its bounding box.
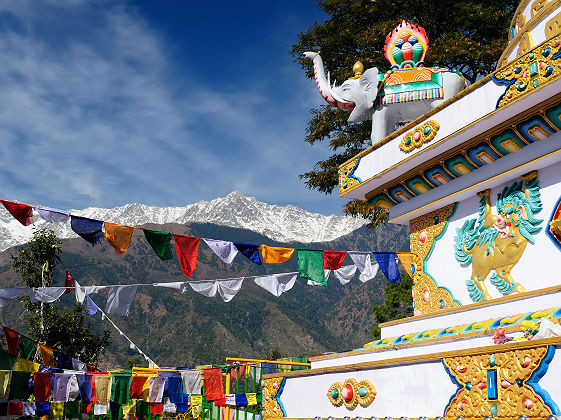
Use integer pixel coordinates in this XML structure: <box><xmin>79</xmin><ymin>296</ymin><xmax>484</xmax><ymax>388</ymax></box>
<box><xmin>442</xmin><ymin>346</ymin><xmax>552</xmax><ymax>418</ymax></box>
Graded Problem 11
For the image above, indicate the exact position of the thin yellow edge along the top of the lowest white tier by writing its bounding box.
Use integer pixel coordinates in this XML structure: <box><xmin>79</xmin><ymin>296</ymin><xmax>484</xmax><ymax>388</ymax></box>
<box><xmin>263</xmin><ymin>337</ymin><xmax>561</xmax><ymax>379</ymax></box>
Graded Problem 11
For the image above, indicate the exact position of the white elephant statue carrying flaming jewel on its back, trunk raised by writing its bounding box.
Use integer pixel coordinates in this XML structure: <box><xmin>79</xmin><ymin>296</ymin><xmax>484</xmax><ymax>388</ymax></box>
<box><xmin>304</xmin><ymin>22</ymin><xmax>465</xmax><ymax>144</ymax></box>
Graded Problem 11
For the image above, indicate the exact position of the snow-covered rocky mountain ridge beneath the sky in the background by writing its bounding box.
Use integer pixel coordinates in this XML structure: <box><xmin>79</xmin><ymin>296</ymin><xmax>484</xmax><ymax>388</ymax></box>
<box><xmin>0</xmin><ymin>191</ymin><xmax>366</xmax><ymax>251</ymax></box>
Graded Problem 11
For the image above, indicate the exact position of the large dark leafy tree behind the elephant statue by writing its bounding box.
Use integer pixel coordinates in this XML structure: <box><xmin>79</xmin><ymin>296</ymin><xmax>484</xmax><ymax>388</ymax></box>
<box><xmin>291</xmin><ymin>0</ymin><xmax>519</xmax><ymax>227</ymax></box>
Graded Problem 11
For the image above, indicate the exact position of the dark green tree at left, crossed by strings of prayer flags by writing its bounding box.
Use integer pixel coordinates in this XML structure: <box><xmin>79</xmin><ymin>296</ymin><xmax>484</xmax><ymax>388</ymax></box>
<box><xmin>12</xmin><ymin>229</ymin><xmax>110</xmax><ymax>364</ymax></box>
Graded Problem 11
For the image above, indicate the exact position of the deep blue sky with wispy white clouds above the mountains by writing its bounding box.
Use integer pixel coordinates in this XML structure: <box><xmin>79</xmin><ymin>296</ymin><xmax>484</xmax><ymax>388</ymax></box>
<box><xmin>0</xmin><ymin>0</ymin><xmax>352</xmax><ymax>214</ymax></box>
